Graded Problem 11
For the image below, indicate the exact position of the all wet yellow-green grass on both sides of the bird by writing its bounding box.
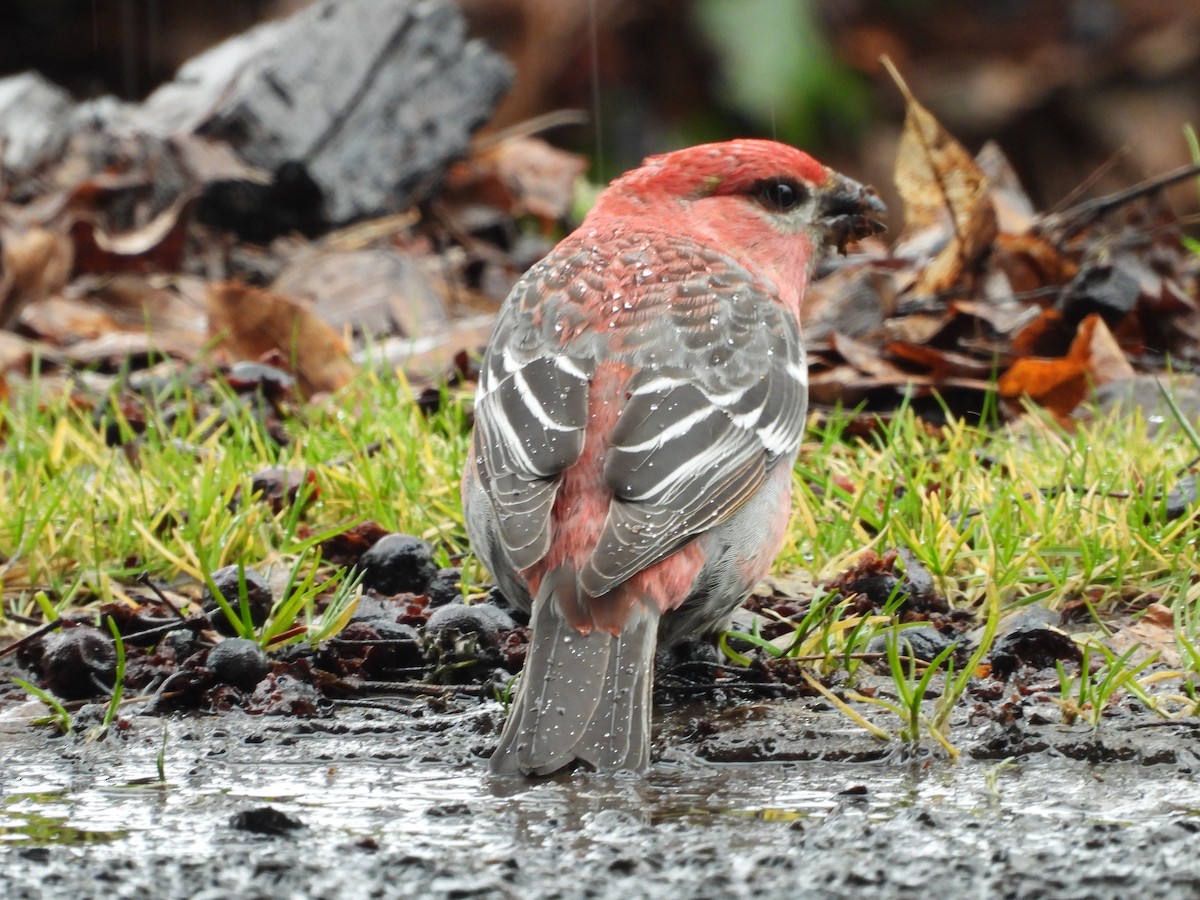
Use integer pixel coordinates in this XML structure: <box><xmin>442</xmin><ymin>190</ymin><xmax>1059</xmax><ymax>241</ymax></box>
<box><xmin>0</xmin><ymin>367</ymin><xmax>1200</xmax><ymax>755</ymax></box>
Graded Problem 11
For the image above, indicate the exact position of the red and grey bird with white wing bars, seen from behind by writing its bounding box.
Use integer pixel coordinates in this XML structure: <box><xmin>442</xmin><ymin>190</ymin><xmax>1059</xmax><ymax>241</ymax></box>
<box><xmin>461</xmin><ymin>138</ymin><xmax>886</xmax><ymax>776</ymax></box>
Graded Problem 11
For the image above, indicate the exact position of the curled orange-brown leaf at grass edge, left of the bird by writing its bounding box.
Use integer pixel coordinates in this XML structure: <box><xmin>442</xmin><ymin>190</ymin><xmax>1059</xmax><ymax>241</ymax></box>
<box><xmin>208</xmin><ymin>282</ymin><xmax>356</xmax><ymax>397</ymax></box>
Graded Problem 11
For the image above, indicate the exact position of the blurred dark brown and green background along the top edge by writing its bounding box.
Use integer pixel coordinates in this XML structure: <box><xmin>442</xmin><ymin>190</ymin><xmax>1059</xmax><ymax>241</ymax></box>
<box><xmin>0</xmin><ymin>0</ymin><xmax>1200</xmax><ymax>211</ymax></box>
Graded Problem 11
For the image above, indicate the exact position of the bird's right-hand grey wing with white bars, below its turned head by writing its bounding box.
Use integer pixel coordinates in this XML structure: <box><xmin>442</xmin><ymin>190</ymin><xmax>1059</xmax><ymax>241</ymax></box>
<box><xmin>580</xmin><ymin>242</ymin><xmax>808</xmax><ymax>596</ymax></box>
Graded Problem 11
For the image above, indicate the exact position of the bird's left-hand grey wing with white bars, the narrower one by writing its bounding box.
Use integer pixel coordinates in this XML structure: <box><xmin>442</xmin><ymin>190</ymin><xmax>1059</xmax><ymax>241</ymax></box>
<box><xmin>473</xmin><ymin>247</ymin><xmax>595</xmax><ymax>571</ymax></box>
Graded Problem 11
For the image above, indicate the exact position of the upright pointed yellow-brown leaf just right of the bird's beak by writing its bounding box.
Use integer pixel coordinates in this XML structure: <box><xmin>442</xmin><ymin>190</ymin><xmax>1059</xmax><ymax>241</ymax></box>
<box><xmin>883</xmin><ymin>59</ymin><xmax>996</xmax><ymax>295</ymax></box>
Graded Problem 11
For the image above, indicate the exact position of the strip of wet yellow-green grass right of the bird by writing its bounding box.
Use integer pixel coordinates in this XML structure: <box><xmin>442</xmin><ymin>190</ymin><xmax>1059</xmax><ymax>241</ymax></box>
<box><xmin>779</xmin><ymin>400</ymin><xmax>1200</xmax><ymax>612</ymax></box>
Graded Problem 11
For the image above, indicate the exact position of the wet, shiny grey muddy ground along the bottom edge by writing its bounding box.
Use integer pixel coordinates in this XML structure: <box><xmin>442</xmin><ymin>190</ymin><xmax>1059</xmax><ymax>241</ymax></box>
<box><xmin>0</xmin><ymin>698</ymin><xmax>1200</xmax><ymax>900</ymax></box>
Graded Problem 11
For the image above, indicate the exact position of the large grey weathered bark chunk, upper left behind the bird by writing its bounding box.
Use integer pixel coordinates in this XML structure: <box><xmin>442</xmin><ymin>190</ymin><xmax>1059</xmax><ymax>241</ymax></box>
<box><xmin>138</xmin><ymin>0</ymin><xmax>510</xmax><ymax>223</ymax></box>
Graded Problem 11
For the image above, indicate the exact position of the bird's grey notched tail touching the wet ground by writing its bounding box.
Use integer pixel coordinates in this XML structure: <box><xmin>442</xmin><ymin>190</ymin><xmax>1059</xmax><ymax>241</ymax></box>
<box><xmin>491</xmin><ymin>568</ymin><xmax>659</xmax><ymax>775</ymax></box>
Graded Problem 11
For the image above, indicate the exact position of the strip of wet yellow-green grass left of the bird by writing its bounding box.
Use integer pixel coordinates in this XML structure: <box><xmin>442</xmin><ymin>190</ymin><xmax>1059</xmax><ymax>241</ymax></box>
<box><xmin>0</xmin><ymin>378</ymin><xmax>467</xmax><ymax>626</ymax></box>
